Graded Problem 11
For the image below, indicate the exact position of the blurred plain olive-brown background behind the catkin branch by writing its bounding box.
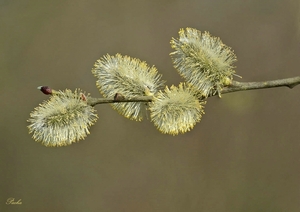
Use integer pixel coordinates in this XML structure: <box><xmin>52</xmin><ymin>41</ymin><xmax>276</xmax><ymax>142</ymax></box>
<box><xmin>0</xmin><ymin>0</ymin><xmax>300</xmax><ymax>212</ymax></box>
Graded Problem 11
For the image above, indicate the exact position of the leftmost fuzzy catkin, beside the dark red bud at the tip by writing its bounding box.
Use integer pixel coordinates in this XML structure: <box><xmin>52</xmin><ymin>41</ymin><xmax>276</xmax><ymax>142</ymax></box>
<box><xmin>28</xmin><ymin>89</ymin><xmax>98</xmax><ymax>146</ymax></box>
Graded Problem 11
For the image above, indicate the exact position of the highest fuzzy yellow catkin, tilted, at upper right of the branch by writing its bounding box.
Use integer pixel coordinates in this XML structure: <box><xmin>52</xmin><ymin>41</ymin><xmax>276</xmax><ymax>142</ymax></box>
<box><xmin>170</xmin><ymin>28</ymin><xmax>236</xmax><ymax>97</ymax></box>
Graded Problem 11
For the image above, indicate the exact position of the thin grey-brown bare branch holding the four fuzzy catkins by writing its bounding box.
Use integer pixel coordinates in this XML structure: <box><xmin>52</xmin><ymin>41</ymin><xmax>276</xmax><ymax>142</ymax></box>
<box><xmin>88</xmin><ymin>76</ymin><xmax>300</xmax><ymax>106</ymax></box>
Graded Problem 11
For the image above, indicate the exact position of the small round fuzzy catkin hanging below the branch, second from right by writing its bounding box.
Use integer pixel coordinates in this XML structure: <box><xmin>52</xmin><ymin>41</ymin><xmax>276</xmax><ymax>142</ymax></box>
<box><xmin>149</xmin><ymin>83</ymin><xmax>206</xmax><ymax>135</ymax></box>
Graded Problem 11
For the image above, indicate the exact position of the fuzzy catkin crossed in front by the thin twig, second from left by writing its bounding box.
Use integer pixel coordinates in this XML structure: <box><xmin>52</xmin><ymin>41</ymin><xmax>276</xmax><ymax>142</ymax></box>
<box><xmin>92</xmin><ymin>54</ymin><xmax>164</xmax><ymax>121</ymax></box>
